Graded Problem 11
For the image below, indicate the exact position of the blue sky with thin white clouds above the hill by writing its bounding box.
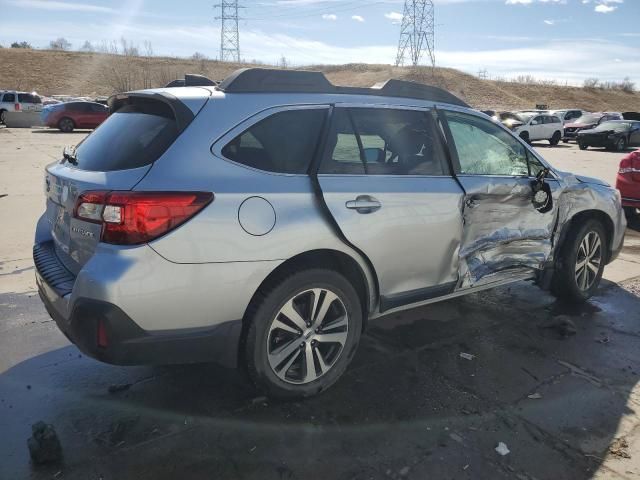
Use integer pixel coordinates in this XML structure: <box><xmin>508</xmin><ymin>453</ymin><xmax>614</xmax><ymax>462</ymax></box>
<box><xmin>0</xmin><ymin>0</ymin><xmax>640</xmax><ymax>85</ymax></box>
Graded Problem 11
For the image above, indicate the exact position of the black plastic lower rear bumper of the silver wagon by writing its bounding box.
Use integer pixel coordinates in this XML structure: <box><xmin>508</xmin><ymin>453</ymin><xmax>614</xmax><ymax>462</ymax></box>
<box><xmin>34</xmin><ymin>245</ymin><xmax>242</xmax><ymax>367</ymax></box>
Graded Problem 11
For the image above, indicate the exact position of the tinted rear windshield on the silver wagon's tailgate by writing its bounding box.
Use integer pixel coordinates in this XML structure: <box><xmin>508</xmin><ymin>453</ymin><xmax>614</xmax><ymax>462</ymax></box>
<box><xmin>75</xmin><ymin>102</ymin><xmax>179</xmax><ymax>172</ymax></box>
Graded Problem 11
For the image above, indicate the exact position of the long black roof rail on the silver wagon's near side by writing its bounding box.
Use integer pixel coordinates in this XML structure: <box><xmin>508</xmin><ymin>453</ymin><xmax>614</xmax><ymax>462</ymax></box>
<box><xmin>217</xmin><ymin>68</ymin><xmax>469</xmax><ymax>107</ymax></box>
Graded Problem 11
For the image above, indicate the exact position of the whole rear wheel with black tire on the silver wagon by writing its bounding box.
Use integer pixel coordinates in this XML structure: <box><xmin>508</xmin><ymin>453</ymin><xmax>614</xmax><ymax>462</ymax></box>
<box><xmin>244</xmin><ymin>268</ymin><xmax>363</xmax><ymax>398</ymax></box>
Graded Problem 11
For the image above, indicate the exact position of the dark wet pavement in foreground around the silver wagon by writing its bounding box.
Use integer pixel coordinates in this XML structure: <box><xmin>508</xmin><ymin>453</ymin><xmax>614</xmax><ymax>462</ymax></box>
<box><xmin>0</xmin><ymin>282</ymin><xmax>640</xmax><ymax>480</ymax></box>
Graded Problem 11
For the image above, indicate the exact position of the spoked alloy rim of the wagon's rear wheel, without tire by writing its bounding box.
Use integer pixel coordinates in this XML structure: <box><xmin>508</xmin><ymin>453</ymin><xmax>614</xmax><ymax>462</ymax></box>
<box><xmin>267</xmin><ymin>288</ymin><xmax>349</xmax><ymax>384</ymax></box>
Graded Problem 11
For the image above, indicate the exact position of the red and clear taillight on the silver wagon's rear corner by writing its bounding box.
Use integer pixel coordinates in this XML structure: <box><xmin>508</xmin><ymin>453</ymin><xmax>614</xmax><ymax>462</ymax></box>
<box><xmin>74</xmin><ymin>191</ymin><xmax>213</xmax><ymax>245</ymax></box>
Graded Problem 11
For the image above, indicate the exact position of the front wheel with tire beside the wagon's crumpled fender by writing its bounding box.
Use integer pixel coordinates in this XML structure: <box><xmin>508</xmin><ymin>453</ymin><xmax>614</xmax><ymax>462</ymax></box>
<box><xmin>551</xmin><ymin>219</ymin><xmax>608</xmax><ymax>303</ymax></box>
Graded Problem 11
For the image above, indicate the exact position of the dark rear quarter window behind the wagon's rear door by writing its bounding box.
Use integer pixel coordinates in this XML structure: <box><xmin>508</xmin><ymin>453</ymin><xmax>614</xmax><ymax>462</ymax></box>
<box><xmin>222</xmin><ymin>107</ymin><xmax>327</xmax><ymax>174</ymax></box>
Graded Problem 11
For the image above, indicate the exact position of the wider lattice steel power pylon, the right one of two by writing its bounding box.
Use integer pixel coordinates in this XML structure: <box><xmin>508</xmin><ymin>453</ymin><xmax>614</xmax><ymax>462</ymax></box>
<box><xmin>396</xmin><ymin>0</ymin><xmax>436</xmax><ymax>67</ymax></box>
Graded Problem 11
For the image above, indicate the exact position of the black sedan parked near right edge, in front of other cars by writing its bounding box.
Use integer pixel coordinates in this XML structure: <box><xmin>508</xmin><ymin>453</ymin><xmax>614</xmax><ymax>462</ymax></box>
<box><xmin>577</xmin><ymin>120</ymin><xmax>640</xmax><ymax>152</ymax></box>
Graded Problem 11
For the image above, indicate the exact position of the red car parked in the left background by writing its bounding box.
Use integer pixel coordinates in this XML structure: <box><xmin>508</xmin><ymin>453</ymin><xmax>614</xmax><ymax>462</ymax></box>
<box><xmin>41</xmin><ymin>102</ymin><xmax>109</xmax><ymax>133</ymax></box>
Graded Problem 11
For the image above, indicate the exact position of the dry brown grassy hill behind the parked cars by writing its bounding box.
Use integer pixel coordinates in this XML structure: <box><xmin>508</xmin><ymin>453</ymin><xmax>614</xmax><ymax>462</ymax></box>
<box><xmin>0</xmin><ymin>48</ymin><xmax>640</xmax><ymax>111</ymax></box>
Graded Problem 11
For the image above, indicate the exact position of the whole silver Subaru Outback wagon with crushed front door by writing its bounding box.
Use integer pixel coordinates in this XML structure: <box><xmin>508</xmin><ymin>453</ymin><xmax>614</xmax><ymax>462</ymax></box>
<box><xmin>33</xmin><ymin>69</ymin><xmax>625</xmax><ymax>397</ymax></box>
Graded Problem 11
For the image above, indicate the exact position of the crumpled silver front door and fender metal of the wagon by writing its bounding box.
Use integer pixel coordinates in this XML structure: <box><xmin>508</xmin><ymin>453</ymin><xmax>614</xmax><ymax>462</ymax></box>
<box><xmin>458</xmin><ymin>172</ymin><xmax>626</xmax><ymax>288</ymax></box>
